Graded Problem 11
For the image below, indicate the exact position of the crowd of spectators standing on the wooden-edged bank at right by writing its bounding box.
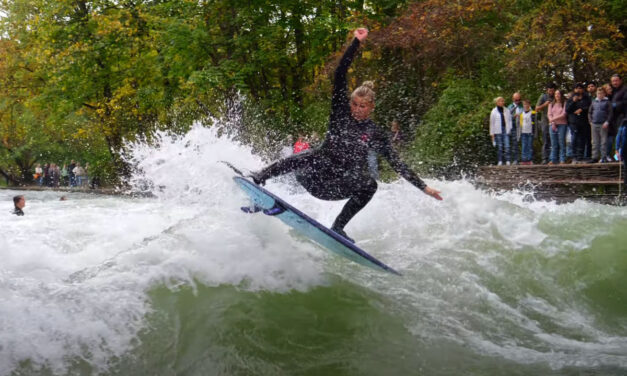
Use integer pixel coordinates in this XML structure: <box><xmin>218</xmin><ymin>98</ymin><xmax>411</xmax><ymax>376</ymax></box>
<box><xmin>490</xmin><ymin>74</ymin><xmax>627</xmax><ymax>167</ymax></box>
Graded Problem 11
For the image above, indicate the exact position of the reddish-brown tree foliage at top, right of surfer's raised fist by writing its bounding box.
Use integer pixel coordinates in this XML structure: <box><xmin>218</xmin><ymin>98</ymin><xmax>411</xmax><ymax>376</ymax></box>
<box><xmin>373</xmin><ymin>0</ymin><xmax>506</xmax><ymax>76</ymax></box>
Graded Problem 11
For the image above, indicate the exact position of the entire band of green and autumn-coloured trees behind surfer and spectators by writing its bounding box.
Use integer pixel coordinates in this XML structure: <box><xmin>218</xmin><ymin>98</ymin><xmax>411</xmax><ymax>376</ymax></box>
<box><xmin>0</xmin><ymin>0</ymin><xmax>627</xmax><ymax>184</ymax></box>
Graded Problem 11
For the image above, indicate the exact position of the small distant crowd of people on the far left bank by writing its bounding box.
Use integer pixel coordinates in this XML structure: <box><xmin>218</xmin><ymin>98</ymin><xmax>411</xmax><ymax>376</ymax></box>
<box><xmin>33</xmin><ymin>160</ymin><xmax>97</xmax><ymax>188</ymax></box>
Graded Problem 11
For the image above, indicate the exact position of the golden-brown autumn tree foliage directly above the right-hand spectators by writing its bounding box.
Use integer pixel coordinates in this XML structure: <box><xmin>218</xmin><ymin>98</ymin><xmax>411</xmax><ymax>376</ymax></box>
<box><xmin>506</xmin><ymin>0</ymin><xmax>627</xmax><ymax>86</ymax></box>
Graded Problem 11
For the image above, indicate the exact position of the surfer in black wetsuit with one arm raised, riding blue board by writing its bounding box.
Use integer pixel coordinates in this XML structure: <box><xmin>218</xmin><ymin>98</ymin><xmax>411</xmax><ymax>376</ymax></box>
<box><xmin>250</xmin><ymin>28</ymin><xmax>442</xmax><ymax>242</ymax></box>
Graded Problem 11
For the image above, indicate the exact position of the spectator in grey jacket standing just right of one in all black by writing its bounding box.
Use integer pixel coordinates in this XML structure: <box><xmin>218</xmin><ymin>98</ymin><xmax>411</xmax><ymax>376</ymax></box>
<box><xmin>588</xmin><ymin>87</ymin><xmax>612</xmax><ymax>163</ymax></box>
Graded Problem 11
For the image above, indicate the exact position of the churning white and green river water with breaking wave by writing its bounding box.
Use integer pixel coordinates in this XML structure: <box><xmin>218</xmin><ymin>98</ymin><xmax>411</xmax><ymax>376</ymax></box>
<box><xmin>0</xmin><ymin>127</ymin><xmax>627</xmax><ymax>375</ymax></box>
